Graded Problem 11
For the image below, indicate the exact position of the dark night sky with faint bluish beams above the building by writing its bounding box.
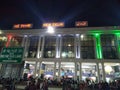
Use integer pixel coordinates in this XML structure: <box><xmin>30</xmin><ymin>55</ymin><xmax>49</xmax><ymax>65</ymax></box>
<box><xmin>0</xmin><ymin>0</ymin><xmax>120</xmax><ymax>29</ymax></box>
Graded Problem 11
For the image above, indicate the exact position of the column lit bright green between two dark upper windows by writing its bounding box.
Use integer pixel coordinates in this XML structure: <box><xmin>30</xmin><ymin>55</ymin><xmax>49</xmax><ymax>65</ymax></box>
<box><xmin>95</xmin><ymin>33</ymin><xmax>103</xmax><ymax>59</ymax></box>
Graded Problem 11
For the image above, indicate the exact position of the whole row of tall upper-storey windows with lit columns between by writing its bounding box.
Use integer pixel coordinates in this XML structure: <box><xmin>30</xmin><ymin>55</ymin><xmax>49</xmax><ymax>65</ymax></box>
<box><xmin>0</xmin><ymin>34</ymin><xmax>119</xmax><ymax>59</ymax></box>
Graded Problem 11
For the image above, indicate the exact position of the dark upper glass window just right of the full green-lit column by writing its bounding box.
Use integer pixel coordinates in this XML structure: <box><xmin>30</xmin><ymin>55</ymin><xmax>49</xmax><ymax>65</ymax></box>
<box><xmin>101</xmin><ymin>34</ymin><xmax>118</xmax><ymax>59</ymax></box>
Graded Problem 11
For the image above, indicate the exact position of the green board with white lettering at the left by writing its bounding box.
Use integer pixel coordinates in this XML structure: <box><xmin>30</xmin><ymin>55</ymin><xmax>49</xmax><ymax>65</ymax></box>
<box><xmin>0</xmin><ymin>47</ymin><xmax>24</xmax><ymax>63</ymax></box>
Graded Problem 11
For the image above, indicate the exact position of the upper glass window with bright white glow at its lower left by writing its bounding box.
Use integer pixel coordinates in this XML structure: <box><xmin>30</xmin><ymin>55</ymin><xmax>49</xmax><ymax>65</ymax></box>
<box><xmin>61</xmin><ymin>35</ymin><xmax>75</xmax><ymax>58</ymax></box>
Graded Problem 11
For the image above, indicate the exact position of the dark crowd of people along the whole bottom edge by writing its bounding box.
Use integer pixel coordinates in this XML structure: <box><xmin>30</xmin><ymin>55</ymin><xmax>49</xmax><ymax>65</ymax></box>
<box><xmin>0</xmin><ymin>77</ymin><xmax>120</xmax><ymax>90</ymax></box>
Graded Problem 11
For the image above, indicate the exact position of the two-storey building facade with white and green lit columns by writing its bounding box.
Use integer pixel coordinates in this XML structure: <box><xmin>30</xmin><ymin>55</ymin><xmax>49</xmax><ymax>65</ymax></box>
<box><xmin>0</xmin><ymin>27</ymin><xmax>120</xmax><ymax>81</ymax></box>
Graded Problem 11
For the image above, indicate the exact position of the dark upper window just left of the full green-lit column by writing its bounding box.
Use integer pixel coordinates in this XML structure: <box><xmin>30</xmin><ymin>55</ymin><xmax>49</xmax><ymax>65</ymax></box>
<box><xmin>80</xmin><ymin>35</ymin><xmax>95</xmax><ymax>59</ymax></box>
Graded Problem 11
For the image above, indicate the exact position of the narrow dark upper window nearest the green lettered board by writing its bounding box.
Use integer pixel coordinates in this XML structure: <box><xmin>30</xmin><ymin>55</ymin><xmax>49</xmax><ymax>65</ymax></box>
<box><xmin>28</xmin><ymin>36</ymin><xmax>39</xmax><ymax>58</ymax></box>
